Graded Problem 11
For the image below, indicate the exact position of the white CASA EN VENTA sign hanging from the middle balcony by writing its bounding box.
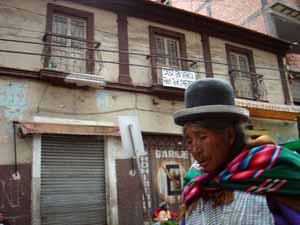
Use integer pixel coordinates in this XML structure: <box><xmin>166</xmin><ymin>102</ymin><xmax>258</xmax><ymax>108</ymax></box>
<box><xmin>161</xmin><ymin>67</ymin><xmax>196</xmax><ymax>89</ymax></box>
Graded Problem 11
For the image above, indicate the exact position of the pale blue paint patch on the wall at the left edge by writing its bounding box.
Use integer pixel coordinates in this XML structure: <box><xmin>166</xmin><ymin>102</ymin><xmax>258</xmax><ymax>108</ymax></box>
<box><xmin>0</xmin><ymin>83</ymin><xmax>27</xmax><ymax>120</ymax></box>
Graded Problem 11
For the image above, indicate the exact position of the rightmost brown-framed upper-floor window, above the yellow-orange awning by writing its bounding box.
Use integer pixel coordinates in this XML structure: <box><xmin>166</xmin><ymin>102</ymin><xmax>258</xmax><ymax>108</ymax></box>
<box><xmin>226</xmin><ymin>44</ymin><xmax>267</xmax><ymax>101</ymax></box>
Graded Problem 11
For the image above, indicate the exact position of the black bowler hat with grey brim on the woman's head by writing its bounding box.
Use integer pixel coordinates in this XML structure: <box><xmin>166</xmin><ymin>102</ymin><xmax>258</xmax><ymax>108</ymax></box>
<box><xmin>174</xmin><ymin>78</ymin><xmax>249</xmax><ymax>126</ymax></box>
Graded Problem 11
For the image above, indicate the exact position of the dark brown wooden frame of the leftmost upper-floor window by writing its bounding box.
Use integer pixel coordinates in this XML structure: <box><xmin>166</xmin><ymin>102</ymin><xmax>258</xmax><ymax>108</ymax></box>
<box><xmin>44</xmin><ymin>3</ymin><xmax>95</xmax><ymax>74</ymax></box>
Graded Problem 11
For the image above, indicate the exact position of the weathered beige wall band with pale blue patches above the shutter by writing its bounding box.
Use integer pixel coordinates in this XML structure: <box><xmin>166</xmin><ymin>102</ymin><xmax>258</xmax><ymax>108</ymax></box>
<box><xmin>0</xmin><ymin>74</ymin><xmax>182</xmax><ymax>164</ymax></box>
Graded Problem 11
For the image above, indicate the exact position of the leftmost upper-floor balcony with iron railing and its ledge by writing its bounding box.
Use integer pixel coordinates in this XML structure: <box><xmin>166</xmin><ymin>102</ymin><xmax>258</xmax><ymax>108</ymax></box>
<box><xmin>41</xmin><ymin>33</ymin><xmax>103</xmax><ymax>86</ymax></box>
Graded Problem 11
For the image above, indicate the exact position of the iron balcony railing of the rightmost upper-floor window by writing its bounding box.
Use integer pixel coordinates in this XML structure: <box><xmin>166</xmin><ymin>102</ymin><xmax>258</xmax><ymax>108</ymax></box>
<box><xmin>229</xmin><ymin>70</ymin><xmax>268</xmax><ymax>101</ymax></box>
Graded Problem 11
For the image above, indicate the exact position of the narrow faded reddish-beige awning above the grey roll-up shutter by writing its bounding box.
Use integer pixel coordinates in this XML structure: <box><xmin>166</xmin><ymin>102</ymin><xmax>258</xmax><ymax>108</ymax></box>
<box><xmin>15</xmin><ymin>121</ymin><xmax>120</xmax><ymax>136</ymax></box>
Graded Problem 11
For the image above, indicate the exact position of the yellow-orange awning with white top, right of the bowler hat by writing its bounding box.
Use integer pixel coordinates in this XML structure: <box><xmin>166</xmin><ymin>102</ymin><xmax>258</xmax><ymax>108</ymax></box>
<box><xmin>236</xmin><ymin>99</ymin><xmax>300</xmax><ymax>121</ymax></box>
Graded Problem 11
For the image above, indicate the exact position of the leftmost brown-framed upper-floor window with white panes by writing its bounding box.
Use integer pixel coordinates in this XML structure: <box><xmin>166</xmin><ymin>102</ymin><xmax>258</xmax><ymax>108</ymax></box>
<box><xmin>44</xmin><ymin>4</ymin><xmax>94</xmax><ymax>73</ymax></box>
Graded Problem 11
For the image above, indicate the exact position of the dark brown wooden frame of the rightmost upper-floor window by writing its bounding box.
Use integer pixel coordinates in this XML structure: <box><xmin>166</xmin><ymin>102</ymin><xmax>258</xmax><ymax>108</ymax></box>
<box><xmin>225</xmin><ymin>44</ymin><xmax>257</xmax><ymax>100</ymax></box>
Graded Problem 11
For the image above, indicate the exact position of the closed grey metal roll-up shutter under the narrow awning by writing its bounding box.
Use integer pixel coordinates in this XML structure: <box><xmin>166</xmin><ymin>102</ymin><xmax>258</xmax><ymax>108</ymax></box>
<box><xmin>40</xmin><ymin>134</ymin><xmax>106</xmax><ymax>225</ymax></box>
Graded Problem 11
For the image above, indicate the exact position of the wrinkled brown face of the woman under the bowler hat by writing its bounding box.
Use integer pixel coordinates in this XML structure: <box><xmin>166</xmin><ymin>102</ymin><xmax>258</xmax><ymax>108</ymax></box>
<box><xmin>184</xmin><ymin>123</ymin><xmax>234</xmax><ymax>172</ymax></box>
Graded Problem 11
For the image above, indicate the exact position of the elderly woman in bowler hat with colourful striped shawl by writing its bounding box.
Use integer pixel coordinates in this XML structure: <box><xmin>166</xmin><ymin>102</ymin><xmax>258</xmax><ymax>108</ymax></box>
<box><xmin>174</xmin><ymin>78</ymin><xmax>300</xmax><ymax>225</ymax></box>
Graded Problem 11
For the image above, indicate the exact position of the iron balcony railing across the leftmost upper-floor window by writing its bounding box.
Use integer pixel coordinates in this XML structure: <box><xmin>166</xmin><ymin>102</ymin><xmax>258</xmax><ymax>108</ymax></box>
<box><xmin>44</xmin><ymin>33</ymin><xmax>103</xmax><ymax>76</ymax></box>
